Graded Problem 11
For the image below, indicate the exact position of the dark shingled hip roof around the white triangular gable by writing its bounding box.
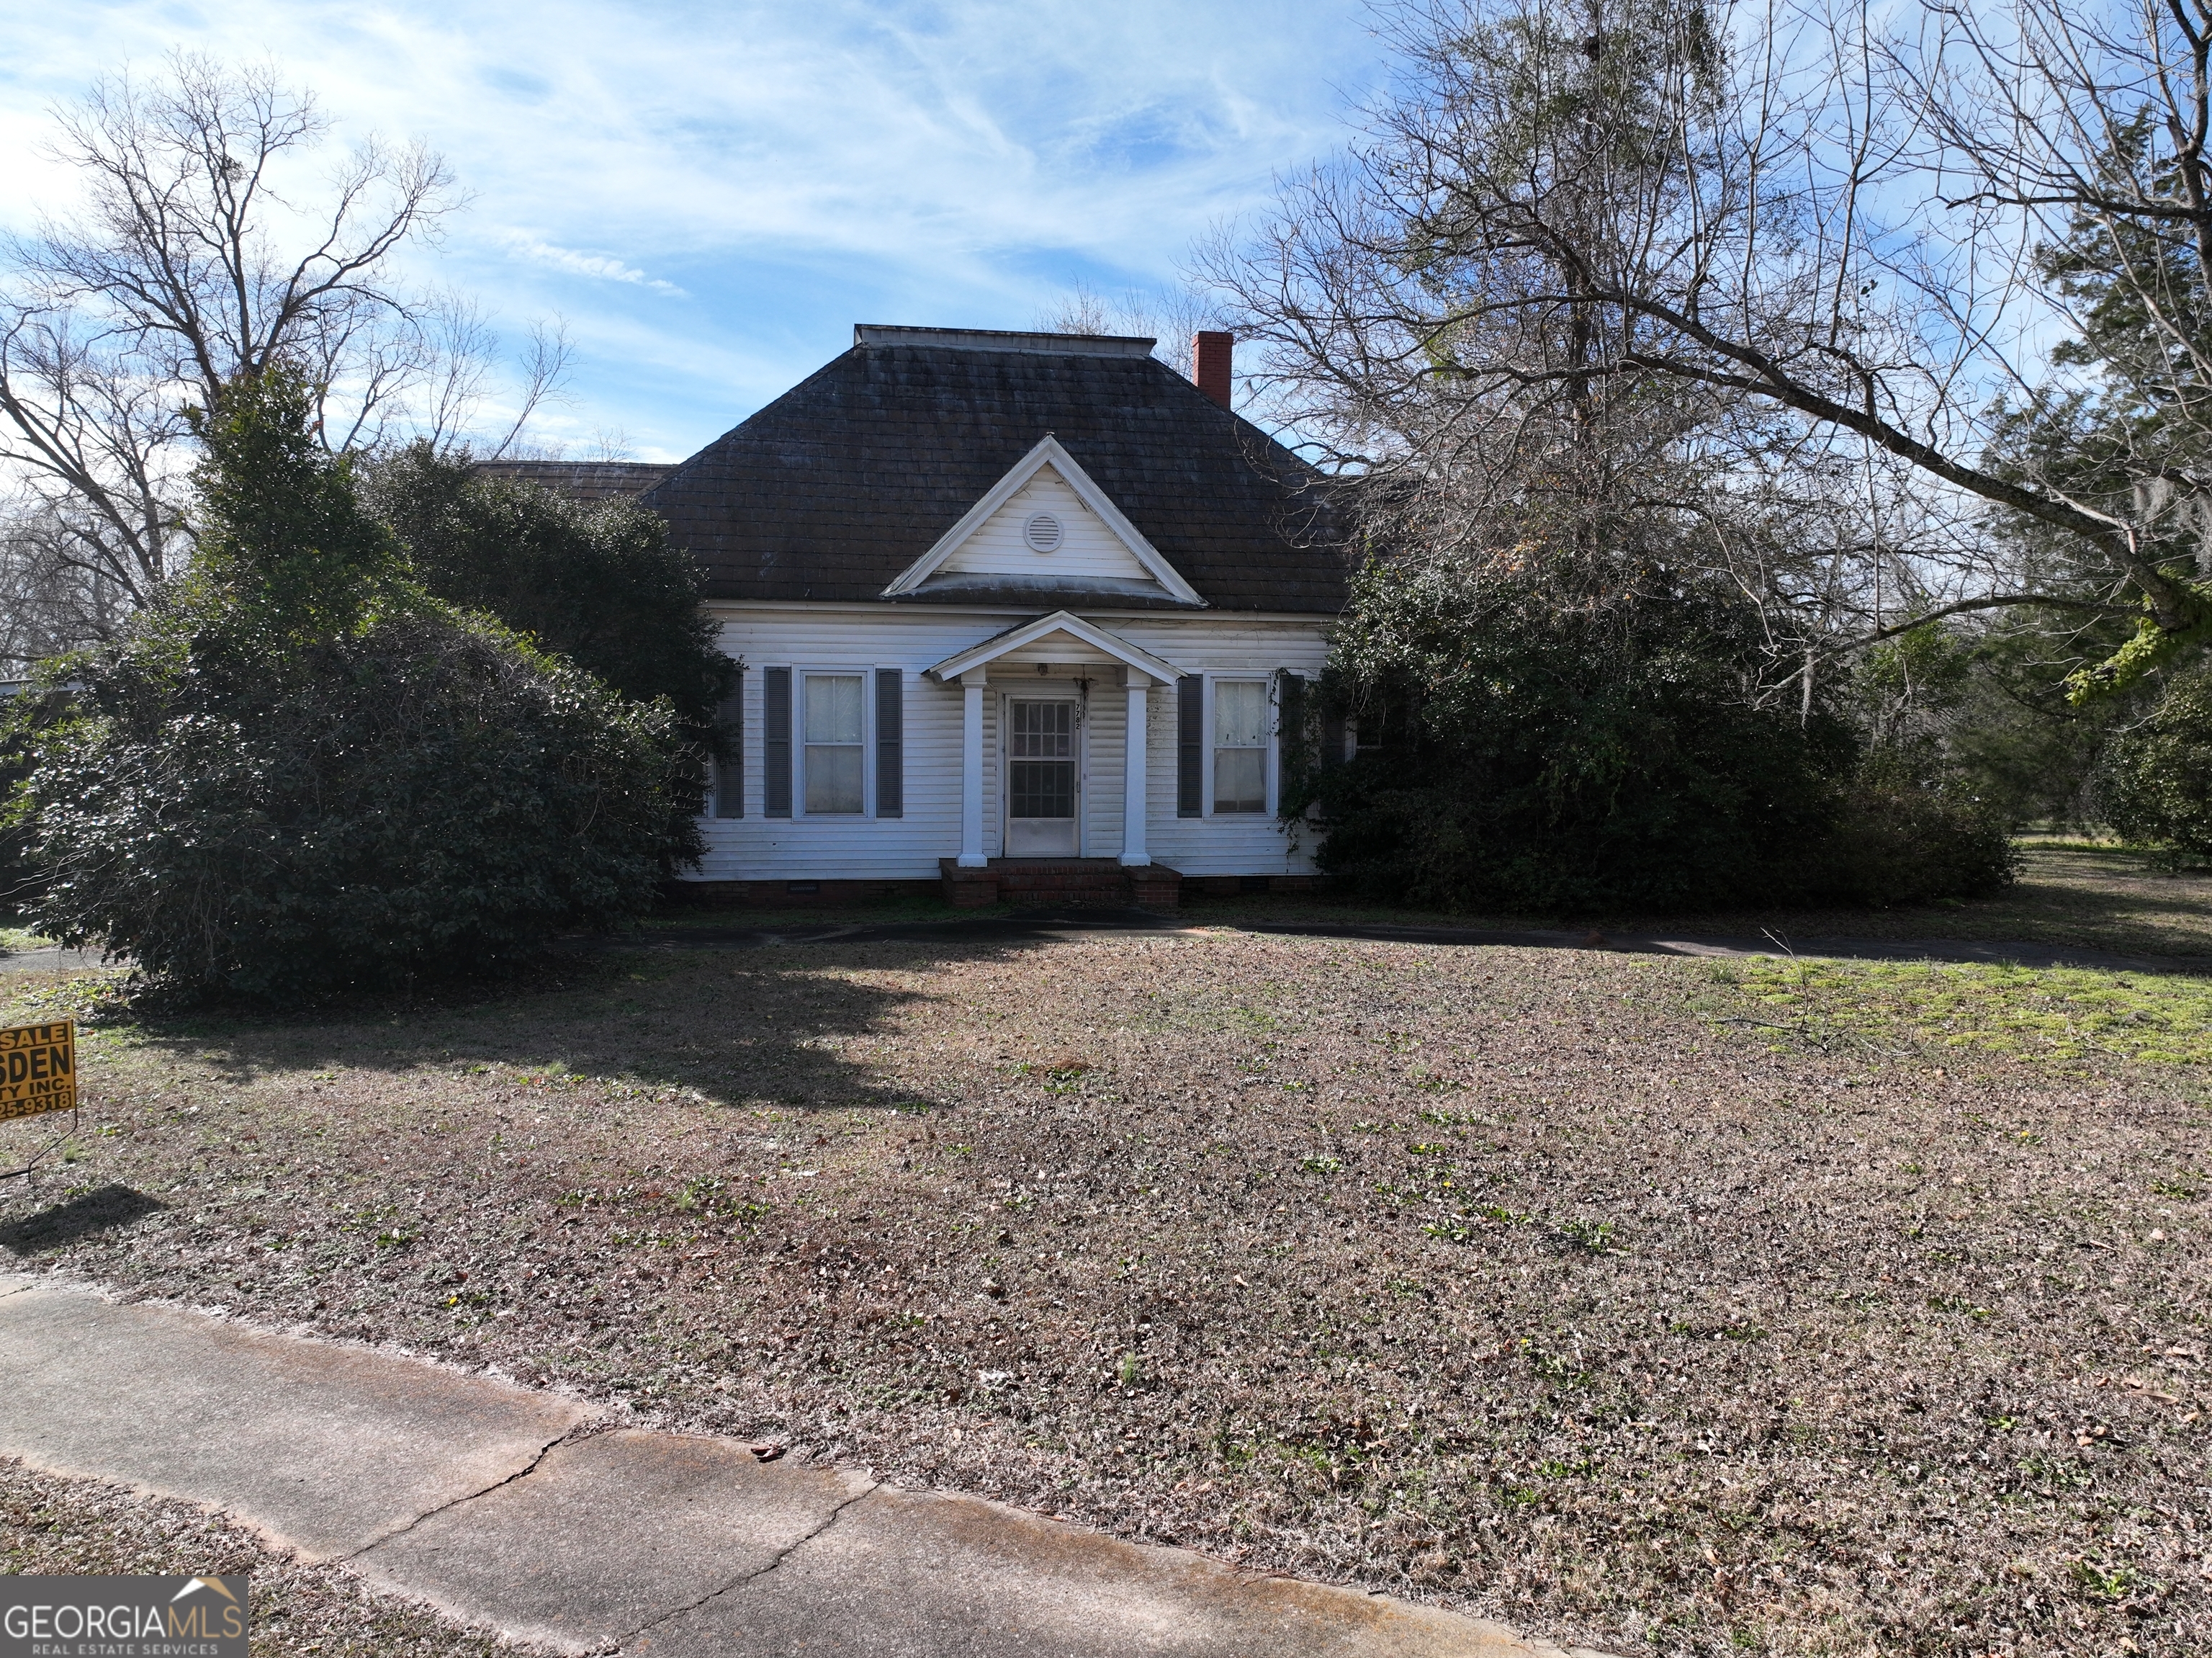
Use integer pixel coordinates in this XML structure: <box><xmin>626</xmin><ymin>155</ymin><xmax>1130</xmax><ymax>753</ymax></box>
<box><xmin>644</xmin><ymin>328</ymin><xmax>1345</xmax><ymax>613</ymax></box>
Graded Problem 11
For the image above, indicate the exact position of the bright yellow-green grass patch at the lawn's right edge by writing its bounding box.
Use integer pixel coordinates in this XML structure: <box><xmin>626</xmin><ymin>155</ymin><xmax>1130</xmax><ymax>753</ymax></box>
<box><xmin>1739</xmin><ymin>956</ymin><xmax>2212</xmax><ymax>1065</ymax></box>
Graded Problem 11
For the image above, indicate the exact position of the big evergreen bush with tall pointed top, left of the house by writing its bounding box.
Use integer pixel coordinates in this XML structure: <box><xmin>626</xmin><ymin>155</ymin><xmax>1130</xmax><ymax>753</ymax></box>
<box><xmin>24</xmin><ymin>376</ymin><xmax>695</xmax><ymax>998</ymax></box>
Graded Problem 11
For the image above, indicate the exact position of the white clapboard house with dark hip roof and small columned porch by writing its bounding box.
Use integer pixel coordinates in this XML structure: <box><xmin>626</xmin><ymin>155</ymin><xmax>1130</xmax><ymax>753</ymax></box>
<box><xmin>521</xmin><ymin>326</ymin><xmax>1345</xmax><ymax>903</ymax></box>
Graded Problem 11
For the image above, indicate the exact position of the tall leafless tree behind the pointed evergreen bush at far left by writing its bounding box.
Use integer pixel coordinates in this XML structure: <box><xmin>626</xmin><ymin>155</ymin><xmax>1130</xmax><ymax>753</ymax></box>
<box><xmin>0</xmin><ymin>55</ymin><xmax>564</xmax><ymax>642</ymax></box>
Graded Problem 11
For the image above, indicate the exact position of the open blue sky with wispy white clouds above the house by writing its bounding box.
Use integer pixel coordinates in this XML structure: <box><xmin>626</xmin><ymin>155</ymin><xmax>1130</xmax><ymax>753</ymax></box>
<box><xmin>0</xmin><ymin>0</ymin><xmax>1382</xmax><ymax>458</ymax></box>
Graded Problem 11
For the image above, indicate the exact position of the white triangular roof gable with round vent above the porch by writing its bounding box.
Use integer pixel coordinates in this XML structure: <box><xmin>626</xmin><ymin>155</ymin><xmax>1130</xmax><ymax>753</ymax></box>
<box><xmin>883</xmin><ymin>434</ymin><xmax>1205</xmax><ymax>609</ymax></box>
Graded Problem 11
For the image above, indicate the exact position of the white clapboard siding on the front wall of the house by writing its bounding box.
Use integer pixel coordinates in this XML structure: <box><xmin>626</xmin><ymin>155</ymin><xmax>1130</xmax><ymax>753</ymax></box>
<box><xmin>693</xmin><ymin>604</ymin><xmax>1327</xmax><ymax>881</ymax></box>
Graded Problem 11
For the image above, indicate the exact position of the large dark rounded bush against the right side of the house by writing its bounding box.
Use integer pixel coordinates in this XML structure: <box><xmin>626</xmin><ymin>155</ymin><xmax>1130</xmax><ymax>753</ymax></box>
<box><xmin>1287</xmin><ymin>549</ymin><xmax>2013</xmax><ymax>914</ymax></box>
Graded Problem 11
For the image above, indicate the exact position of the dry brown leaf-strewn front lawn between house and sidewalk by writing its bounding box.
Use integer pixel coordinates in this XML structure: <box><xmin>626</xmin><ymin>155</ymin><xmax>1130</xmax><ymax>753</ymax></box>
<box><xmin>0</xmin><ymin>932</ymin><xmax>2212</xmax><ymax>1654</ymax></box>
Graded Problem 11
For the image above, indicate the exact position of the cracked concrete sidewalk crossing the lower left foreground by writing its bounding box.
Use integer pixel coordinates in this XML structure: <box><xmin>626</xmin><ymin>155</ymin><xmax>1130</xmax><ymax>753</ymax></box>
<box><xmin>0</xmin><ymin>1275</ymin><xmax>1599</xmax><ymax>1658</ymax></box>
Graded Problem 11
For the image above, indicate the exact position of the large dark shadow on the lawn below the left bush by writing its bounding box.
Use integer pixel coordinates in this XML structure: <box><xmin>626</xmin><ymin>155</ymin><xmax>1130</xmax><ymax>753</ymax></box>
<box><xmin>95</xmin><ymin>936</ymin><xmax>1031</xmax><ymax>1109</ymax></box>
